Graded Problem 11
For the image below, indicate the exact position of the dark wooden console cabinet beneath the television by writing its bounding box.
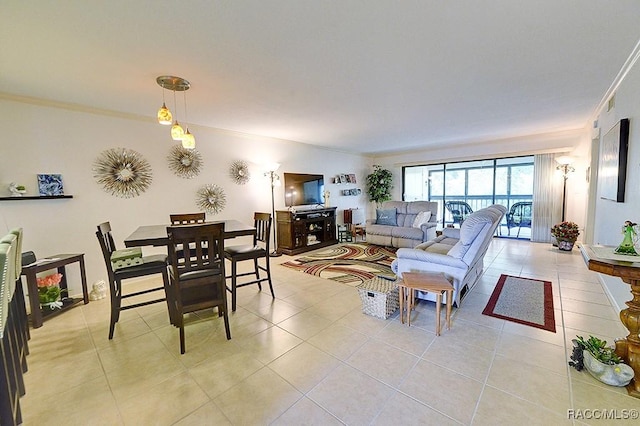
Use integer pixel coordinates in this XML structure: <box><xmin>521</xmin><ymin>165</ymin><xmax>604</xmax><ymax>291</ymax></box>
<box><xmin>276</xmin><ymin>207</ymin><xmax>338</xmax><ymax>255</ymax></box>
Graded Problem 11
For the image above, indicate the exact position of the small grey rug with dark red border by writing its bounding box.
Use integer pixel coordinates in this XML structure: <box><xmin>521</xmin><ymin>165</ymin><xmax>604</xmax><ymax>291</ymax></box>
<box><xmin>482</xmin><ymin>274</ymin><xmax>556</xmax><ymax>333</ymax></box>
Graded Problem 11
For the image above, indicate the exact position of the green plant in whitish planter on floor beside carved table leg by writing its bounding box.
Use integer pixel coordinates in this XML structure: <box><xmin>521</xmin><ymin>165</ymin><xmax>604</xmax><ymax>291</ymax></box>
<box><xmin>569</xmin><ymin>336</ymin><xmax>634</xmax><ymax>386</ymax></box>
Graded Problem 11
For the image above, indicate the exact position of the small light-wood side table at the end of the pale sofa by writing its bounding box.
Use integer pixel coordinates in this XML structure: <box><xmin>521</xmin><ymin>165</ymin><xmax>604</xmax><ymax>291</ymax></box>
<box><xmin>398</xmin><ymin>272</ymin><xmax>453</xmax><ymax>336</ymax></box>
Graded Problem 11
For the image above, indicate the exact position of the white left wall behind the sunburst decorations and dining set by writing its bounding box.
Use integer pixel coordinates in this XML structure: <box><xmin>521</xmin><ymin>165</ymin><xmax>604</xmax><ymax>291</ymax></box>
<box><xmin>0</xmin><ymin>96</ymin><xmax>370</xmax><ymax>294</ymax></box>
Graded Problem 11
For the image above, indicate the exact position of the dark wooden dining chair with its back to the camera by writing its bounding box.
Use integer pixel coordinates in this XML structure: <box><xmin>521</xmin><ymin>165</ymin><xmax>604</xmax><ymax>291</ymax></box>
<box><xmin>167</xmin><ymin>223</ymin><xmax>231</xmax><ymax>354</ymax></box>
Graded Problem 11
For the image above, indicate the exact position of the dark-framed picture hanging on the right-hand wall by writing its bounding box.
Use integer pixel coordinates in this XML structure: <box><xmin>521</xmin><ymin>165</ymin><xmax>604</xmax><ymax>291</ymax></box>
<box><xmin>598</xmin><ymin>118</ymin><xmax>629</xmax><ymax>203</ymax></box>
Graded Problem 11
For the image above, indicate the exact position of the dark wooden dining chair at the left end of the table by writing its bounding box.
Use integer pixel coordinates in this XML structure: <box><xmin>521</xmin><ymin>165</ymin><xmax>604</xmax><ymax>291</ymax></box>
<box><xmin>96</xmin><ymin>222</ymin><xmax>171</xmax><ymax>339</ymax></box>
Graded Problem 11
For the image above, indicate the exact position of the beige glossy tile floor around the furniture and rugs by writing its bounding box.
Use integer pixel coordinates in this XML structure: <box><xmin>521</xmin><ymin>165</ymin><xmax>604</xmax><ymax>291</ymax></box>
<box><xmin>21</xmin><ymin>239</ymin><xmax>640</xmax><ymax>425</ymax></box>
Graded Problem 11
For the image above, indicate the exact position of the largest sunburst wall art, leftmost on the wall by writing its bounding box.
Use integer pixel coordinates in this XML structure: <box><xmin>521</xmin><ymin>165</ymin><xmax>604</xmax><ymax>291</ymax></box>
<box><xmin>93</xmin><ymin>148</ymin><xmax>152</xmax><ymax>198</ymax></box>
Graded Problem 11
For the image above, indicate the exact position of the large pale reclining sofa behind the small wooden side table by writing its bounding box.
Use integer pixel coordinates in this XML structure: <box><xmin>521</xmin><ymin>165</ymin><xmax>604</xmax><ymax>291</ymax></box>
<box><xmin>390</xmin><ymin>204</ymin><xmax>507</xmax><ymax>307</ymax></box>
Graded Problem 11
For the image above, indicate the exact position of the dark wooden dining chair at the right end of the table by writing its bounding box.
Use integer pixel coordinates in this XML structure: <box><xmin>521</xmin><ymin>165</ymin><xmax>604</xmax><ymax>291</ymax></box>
<box><xmin>224</xmin><ymin>212</ymin><xmax>276</xmax><ymax>311</ymax></box>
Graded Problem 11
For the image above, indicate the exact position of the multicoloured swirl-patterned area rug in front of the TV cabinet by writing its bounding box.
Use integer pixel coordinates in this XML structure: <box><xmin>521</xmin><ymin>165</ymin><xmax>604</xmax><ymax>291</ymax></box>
<box><xmin>281</xmin><ymin>243</ymin><xmax>396</xmax><ymax>285</ymax></box>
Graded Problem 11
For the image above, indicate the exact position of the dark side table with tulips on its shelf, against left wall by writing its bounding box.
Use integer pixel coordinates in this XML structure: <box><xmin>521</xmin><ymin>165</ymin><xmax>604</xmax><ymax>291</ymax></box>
<box><xmin>22</xmin><ymin>254</ymin><xmax>89</xmax><ymax>328</ymax></box>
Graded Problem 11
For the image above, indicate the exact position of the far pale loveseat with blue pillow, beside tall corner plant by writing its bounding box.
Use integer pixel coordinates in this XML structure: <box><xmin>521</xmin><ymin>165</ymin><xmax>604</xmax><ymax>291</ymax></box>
<box><xmin>367</xmin><ymin>201</ymin><xmax>438</xmax><ymax>248</ymax></box>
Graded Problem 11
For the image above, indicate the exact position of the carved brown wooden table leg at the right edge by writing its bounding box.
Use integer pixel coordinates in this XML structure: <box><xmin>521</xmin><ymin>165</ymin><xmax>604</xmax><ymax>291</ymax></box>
<box><xmin>616</xmin><ymin>280</ymin><xmax>640</xmax><ymax>398</ymax></box>
